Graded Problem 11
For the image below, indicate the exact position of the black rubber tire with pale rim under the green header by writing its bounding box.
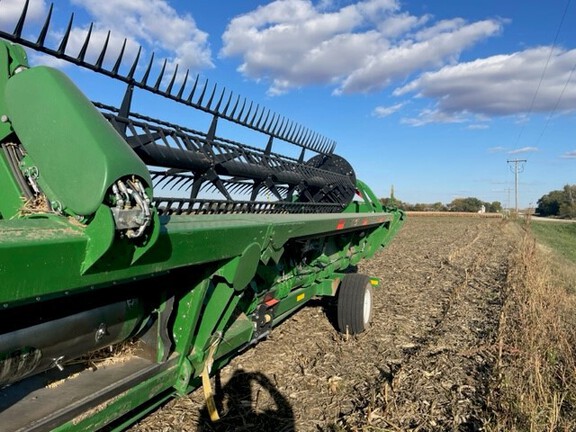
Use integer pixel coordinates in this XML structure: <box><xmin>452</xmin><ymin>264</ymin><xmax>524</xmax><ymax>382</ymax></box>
<box><xmin>336</xmin><ymin>273</ymin><xmax>373</xmax><ymax>334</ymax></box>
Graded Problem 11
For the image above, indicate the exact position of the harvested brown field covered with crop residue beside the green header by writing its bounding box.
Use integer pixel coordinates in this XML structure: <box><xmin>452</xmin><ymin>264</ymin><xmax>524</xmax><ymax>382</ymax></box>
<box><xmin>130</xmin><ymin>217</ymin><xmax>514</xmax><ymax>432</ymax></box>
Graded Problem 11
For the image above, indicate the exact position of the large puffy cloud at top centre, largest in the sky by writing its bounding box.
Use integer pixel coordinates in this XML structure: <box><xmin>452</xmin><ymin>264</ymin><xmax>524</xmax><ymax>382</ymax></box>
<box><xmin>220</xmin><ymin>0</ymin><xmax>502</xmax><ymax>94</ymax></box>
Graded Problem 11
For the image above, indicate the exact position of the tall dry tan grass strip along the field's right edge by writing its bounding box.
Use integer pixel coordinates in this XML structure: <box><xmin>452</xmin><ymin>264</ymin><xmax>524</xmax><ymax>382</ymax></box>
<box><xmin>487</xmin><ymin>228</ymin><xmax>576</xmax><ymax>431</ymax></box>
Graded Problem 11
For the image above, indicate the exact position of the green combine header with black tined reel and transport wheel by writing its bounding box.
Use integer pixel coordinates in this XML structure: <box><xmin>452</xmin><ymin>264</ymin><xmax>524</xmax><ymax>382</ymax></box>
<box><xmin>0</xmin><ymin>2</ymin><xmax>404</xmax><ymax>431</ymax></box>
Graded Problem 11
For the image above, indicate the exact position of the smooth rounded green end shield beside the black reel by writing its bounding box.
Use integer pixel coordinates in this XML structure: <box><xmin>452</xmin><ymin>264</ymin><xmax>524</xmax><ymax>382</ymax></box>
<box><xmin>5</xmin><ymin>66</ymin><xmax>152</xmax><ymax>215</ymax></box>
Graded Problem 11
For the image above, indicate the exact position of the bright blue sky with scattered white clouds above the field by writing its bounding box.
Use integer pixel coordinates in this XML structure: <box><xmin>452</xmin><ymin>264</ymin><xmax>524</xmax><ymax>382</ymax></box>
<box><xmin>0</xmin><ymin>0</ymin><xmax>576</xmax><ymax>207</ymax></box>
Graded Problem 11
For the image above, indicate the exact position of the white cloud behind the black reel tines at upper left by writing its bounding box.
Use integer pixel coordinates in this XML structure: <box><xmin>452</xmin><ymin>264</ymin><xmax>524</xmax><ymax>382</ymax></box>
<box><xmin>5</xmin><ymin>0</ymin><xmax>213</xmax><ymax>76</ymax></box>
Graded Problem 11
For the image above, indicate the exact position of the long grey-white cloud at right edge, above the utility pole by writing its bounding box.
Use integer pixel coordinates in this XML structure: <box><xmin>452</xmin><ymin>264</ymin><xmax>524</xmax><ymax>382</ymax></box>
<box><xmin>394</xmin><ymin>47</ymin><xmax>576</xmax><ymax>116</ymax></box>
